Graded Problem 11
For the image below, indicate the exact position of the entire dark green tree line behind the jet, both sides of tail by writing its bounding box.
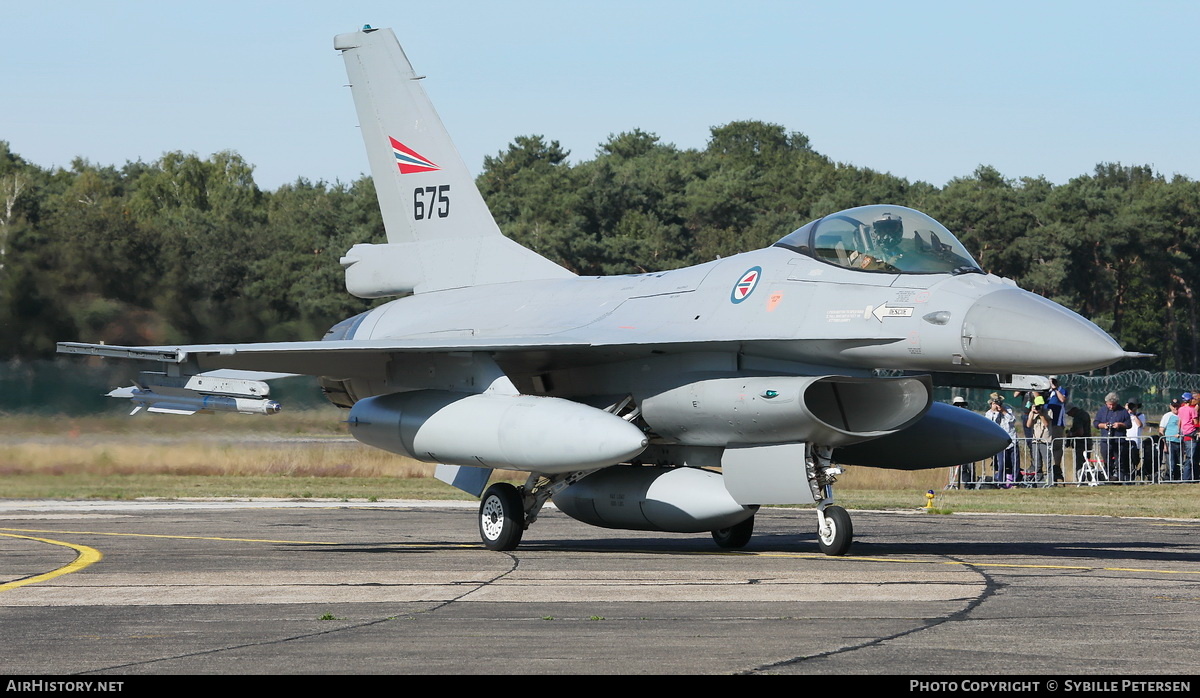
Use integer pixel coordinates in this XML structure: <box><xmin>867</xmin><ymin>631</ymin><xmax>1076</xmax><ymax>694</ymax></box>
<box><xmin>0</xmin><ymin>121</ymin><xmax>1200</xmax><ymax>373</ymax></box>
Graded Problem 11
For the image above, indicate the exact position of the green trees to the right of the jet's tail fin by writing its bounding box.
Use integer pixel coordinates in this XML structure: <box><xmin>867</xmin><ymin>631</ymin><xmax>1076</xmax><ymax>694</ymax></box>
<box><xmin>480</xmin><ymin>130</ymin><xmax>1200</xmax><ymax>371</ymax></box>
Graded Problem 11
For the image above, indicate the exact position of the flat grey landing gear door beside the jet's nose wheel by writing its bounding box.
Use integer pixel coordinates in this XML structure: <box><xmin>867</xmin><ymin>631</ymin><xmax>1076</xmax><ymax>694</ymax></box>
<box><xmin>721</xmin><ymin>444</ymin><xmax>816</xmax><ymax>505</ymax></box>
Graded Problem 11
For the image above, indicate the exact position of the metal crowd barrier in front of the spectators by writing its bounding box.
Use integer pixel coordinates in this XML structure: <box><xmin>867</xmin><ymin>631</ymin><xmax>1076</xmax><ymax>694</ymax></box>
<box><xmin>947</xmin><ymin>437</ymin><xmax>1200</xmax><ymax>489</ymax></box>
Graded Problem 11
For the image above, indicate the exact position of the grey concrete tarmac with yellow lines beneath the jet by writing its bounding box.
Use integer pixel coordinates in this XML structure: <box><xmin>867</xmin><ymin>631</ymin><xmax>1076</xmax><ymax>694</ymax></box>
<box><xmin>0</xmin><ymin>501</ymin><xmax>1200</xmax><ymax>678</ymax></box>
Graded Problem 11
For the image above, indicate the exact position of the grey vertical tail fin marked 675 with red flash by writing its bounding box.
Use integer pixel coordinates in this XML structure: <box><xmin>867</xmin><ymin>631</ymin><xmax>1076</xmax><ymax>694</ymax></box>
<box><xmin>334</xmin><ymin>28</ymin><xmax>571</xmax><ymax>297</ymax></box>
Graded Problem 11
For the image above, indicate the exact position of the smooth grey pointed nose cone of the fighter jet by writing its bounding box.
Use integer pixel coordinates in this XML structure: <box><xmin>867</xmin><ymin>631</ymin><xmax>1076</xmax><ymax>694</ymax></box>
<box><xmin>962</xmin><ymin>289</ymin><xmax>1126</xmax><ymax>374</ymax></box>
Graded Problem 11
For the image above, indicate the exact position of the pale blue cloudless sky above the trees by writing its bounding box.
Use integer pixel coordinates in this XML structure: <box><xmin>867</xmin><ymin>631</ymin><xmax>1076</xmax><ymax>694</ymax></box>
<box><xmin>9</xmin><ymin>0</ymin><xmax>1200</xmax><ymax>188</ymax></box>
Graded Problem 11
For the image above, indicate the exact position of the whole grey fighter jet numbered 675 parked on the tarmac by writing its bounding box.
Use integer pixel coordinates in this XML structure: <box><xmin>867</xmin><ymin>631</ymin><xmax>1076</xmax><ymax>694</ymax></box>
<box><xmin>59</xmin><ymin>26</ymin><xmax>1127</xmax><ymax>555</ymax></box>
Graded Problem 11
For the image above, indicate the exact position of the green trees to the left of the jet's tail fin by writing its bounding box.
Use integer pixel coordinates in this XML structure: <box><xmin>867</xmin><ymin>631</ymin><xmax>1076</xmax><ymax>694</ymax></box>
<box><xmin>0</xmin><ymin>149</ymin><xmax>383</xmax><ymax>357</ymax></box>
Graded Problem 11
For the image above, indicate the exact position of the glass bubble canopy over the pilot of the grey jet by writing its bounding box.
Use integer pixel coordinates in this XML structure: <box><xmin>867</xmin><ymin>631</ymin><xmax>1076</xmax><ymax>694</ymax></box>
<box><xmin>775</xmin><ymin>205</ymin><xmax>983</xmax><ymax>275</ymax></box>
